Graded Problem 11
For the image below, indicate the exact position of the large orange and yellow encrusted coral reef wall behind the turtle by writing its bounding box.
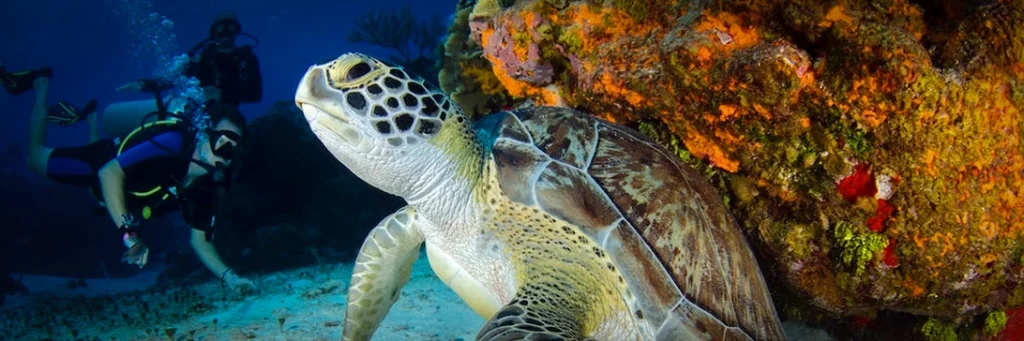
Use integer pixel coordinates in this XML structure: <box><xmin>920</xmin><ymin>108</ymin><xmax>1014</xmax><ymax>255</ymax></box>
<box><xmin>439</xmin><ymin>0</ymin><xmax>1024</xmax><ymax>338</ymax></box>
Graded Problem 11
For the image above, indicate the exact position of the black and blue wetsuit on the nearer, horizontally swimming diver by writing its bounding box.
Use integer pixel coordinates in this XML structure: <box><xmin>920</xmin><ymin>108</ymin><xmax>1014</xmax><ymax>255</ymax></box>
<box><xmin>46</xmin><ymin>123</ymin><xmax>215</xmax><ymax>232</ymax></box>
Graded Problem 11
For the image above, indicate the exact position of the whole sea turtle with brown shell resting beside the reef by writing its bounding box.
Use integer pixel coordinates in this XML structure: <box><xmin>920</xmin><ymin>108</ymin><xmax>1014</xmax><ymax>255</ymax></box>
<box><xmin>295</xmin><ymin>53</ymin><xmax>784</xmax><ymax>341</ymax></box>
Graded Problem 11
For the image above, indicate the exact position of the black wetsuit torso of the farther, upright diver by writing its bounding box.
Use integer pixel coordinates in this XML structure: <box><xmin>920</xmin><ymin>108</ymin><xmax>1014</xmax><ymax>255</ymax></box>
<box><xmin>185</xmin><ymin>45</ymin><xmax>263</xmax><ymax>105</ymax></box>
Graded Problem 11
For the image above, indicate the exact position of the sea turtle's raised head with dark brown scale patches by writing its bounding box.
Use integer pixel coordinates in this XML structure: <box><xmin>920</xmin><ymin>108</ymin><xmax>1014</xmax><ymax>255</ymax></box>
<box><xmin>295</xmin><ymin>53</ymin><xmax>468</xmax><ymax>199</ymax></box>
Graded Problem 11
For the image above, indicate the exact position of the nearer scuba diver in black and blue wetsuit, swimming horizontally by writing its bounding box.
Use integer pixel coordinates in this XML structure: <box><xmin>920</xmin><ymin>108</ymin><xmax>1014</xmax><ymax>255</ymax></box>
<box><xmin>0</xmin><ymin>62</ymin><xmax>255</xmax><ymax>290</ymax></box>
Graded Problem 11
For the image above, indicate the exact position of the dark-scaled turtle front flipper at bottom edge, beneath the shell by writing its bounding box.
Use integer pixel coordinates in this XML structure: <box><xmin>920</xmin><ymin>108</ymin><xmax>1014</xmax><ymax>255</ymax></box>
<box><xmin>476</xmin><ymin>286</ymin><xmax>594</xmax><ymax>341</ymax></box>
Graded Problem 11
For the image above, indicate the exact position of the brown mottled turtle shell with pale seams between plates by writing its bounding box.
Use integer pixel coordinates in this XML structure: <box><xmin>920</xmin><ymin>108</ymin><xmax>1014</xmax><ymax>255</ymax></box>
<box><xmin>476</xmin><ymin>106</ymin><xmax>784</xmax><ymax>340</ymax></box>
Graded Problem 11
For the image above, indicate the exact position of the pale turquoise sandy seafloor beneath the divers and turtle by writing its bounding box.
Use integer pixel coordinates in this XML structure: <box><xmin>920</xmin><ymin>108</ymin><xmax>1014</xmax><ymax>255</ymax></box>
<box><xmin>0</xmin><ymin>248</ymin><xmax>829</xmax><ymax>341</ymax></box>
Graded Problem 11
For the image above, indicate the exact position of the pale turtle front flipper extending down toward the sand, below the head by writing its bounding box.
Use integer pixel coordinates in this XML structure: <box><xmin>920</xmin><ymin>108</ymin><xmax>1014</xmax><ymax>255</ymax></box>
<box><xmin>343</xmin><ymin>207</ymin><xmax>424</xmax><ymax>340</ymax></box>
